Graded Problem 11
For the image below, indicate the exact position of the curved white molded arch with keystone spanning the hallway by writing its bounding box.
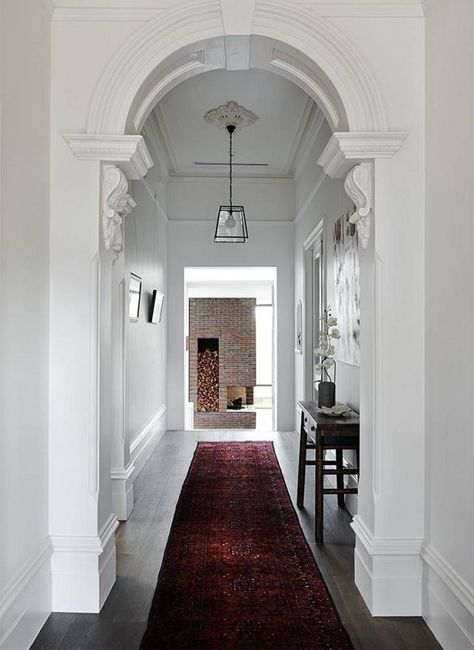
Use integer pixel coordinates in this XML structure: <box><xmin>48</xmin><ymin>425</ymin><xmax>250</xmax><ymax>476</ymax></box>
<box><xmin>86</xmin><ymin>0</ymin><xmax>387</xmax><ymax>135</ymax></box>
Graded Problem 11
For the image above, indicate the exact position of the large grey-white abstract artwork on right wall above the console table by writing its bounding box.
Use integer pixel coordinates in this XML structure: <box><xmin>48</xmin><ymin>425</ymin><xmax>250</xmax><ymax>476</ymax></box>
<box><xmin>333</xmin><ymin>214</ymin><xmax>360</xmax><ymax>366</ymax></box>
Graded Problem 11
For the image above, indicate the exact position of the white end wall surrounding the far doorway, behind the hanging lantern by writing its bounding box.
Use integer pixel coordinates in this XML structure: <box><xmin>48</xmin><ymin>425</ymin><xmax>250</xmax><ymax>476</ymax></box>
<box><xmin>168</xmin><ymin>219</ymin><xmax>295</xmax><ymax>431</ymax></box>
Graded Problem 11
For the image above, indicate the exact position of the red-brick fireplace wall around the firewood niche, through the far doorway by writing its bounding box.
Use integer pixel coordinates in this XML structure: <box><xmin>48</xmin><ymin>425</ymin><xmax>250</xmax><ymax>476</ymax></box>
<box><xmin>189</xmin><ymin>298</ymin><xmax>257</xmax><ymax>429</ymax></box>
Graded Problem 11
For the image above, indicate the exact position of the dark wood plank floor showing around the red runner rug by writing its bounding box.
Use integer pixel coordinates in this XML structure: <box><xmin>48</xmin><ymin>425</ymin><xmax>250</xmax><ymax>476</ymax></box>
<box><xmin>32</xmin><ymin>431</ymin><xmax>440</xmax><ymax>650</ymax></box>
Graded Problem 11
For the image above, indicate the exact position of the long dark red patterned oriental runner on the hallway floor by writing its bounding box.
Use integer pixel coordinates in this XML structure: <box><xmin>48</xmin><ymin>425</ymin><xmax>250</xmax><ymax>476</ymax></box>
<box><xmin>141</xmin><ymin>442</ymin><xmax>353</xmax><ymax>650</ymax></box>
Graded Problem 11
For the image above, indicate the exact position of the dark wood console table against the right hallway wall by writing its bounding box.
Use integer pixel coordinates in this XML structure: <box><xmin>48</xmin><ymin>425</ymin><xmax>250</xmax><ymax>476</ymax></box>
<box><xmin>296</xmin><ymin>402</ymin><xmax>359</xmax><ymax>544</ymax></box>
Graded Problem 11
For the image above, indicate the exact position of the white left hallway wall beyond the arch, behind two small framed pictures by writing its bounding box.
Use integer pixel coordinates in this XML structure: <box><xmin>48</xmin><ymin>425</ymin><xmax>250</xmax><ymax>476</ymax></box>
<box><xmin>124</xmin><ymin>181</ymin><xmax>168</xmax><ymax>466</ymax></box>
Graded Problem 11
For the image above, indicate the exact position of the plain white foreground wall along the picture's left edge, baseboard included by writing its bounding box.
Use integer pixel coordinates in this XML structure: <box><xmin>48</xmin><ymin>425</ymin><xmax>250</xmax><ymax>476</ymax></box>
<box><xmin>0</xmin><ymin>0</ymin><xmax>51</xmax><ymax>648</ymax></box>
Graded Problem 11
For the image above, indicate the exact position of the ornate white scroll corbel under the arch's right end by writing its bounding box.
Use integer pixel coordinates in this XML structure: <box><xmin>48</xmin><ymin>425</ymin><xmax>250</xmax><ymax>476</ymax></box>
<box><xmin>344</xmin><ymin>163</ymin><xmax>372</xmax><ymax>248</ymax></box>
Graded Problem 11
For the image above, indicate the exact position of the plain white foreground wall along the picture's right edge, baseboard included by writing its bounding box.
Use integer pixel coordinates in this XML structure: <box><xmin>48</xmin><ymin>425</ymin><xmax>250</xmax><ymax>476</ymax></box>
<box><xmin>424</xmin><ymin>0</ymin><xmax>474</xmax><ymax>649</ymax></box>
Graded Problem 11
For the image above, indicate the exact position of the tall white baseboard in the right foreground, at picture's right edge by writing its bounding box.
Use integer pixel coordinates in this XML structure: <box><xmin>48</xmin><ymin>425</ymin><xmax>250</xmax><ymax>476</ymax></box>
<box><xmin>422</xmin><ymin>545</ymin><xmax>474</xmax><ymax>650</ymax></box>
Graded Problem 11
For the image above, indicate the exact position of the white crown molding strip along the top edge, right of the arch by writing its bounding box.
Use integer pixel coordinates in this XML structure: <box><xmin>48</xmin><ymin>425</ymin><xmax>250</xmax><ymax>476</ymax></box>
<box><xmin>298</xmin><ymin>0</ymin><xmax>424</xmax><ymax>18</ymax></box>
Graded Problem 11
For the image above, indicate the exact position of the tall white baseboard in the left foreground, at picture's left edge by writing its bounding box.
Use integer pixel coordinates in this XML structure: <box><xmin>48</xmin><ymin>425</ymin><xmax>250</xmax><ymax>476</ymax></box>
<box><xmin>0</xmin><ymin>538</ymin><xmax>51</xmax><ymax>650</ymax></box>
